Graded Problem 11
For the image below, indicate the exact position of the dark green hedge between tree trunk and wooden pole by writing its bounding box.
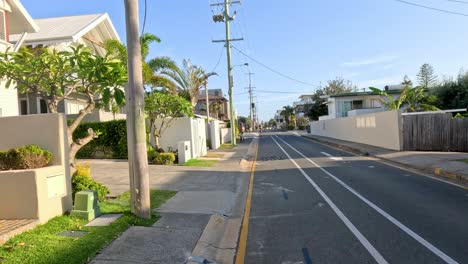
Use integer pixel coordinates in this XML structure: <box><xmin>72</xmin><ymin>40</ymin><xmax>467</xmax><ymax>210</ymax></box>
<box><xmin>73</xmin><ymin>120</ymin><xmax>128</xmax><ymax>159</ymax></box>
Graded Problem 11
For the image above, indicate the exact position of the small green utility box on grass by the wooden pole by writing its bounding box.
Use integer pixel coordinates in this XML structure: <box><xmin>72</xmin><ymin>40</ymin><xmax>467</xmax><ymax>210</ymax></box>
<box><xmin>70</xmin><ymin>190</ymin><xmax>101</xmax><ymax>221</ymax></box>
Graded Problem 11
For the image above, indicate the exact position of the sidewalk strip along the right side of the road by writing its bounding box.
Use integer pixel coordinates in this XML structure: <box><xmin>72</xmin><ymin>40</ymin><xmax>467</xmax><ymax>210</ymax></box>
<box><xmin>302</xmin><ymin>134</ymin><xmax>468</xmax><ymax>184</ymax></box>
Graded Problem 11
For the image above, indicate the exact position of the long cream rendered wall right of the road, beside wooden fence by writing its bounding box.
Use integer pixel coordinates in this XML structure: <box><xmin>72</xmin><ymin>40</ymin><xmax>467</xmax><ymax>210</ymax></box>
<box><xmin>310</xmin><ymin>111</ymin><xmax>402</xmax><ymax>150</ymax></box>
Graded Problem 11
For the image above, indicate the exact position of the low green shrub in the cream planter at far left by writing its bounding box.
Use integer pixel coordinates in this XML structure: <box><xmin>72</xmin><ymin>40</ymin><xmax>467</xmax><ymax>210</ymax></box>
<box><xmin>0</xmin><ymin>145</ymin><xmax>52</xmax><ymax>170</ymax></box>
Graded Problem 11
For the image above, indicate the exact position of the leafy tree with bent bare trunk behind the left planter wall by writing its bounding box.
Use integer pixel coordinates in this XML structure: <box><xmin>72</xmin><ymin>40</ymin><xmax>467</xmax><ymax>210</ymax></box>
<box><xmin>0</xmin><ymin>45</ymin><xmax>127</xmax><ymax>167</ymax></box>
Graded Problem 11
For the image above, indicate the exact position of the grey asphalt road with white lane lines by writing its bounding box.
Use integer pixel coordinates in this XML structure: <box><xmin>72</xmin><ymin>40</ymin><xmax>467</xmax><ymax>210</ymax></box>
<box><xmin>245</xmin><ymin>133</ymin><xmax>468</xmax><ymax>264</ymax></box>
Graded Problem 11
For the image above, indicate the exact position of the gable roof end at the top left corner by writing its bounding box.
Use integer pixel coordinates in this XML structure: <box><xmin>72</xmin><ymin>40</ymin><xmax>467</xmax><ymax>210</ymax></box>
<box><xmin>4</xmin><ymin>0</ymin><xmax>39</xmax><ymax>34</ymax></box>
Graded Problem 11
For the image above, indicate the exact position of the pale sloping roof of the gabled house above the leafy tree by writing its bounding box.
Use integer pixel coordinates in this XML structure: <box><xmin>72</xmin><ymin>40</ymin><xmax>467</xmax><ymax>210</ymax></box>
<box><xmin>10</xmin><ymin>13</ymin><xmax>119</xmax><ymax>43</ymax></box>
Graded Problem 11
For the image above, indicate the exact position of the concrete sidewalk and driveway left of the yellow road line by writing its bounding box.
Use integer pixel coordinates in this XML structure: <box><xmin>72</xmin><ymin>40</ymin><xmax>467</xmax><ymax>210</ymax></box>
<box><xmin>87</xmin><ymin>135</ymin><xmax>258</xmax><ymax>264</ymax></box>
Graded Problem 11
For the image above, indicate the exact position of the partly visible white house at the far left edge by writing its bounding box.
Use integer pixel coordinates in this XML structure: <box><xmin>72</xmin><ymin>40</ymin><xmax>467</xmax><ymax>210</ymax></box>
<box><xmin>0</xmin><ymin>0</ymin><xmax>39</xmax><ymax>117</ymax></box>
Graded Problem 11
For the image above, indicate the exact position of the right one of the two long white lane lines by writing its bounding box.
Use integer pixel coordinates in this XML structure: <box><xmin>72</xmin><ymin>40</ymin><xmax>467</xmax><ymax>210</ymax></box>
<box><xmin>276</xmin><ymin>136</ymin><xmax>458</xmax><ymax>264</ymax></box>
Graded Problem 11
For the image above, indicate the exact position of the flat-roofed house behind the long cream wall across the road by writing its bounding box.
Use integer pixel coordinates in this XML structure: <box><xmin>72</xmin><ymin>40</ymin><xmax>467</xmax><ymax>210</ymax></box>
<box><xmin>319</xmin><ymin>85</ymin><xmax>404</xmax><ymax>120</ymax></box>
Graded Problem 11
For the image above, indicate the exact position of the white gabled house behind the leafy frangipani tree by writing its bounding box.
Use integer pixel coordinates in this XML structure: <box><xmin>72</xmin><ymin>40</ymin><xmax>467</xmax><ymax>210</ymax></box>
<box><xmin>11</xmin><ymin>13</ymin><xmax>125</xmax><ymax>121</ymax></box>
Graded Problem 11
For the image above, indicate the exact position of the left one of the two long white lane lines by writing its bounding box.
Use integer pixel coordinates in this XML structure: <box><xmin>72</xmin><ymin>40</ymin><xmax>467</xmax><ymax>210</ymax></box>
<box><xmin>272</xmin><ymin>137</ymin><xmax>388</xmax><ymax>264</ymax></box>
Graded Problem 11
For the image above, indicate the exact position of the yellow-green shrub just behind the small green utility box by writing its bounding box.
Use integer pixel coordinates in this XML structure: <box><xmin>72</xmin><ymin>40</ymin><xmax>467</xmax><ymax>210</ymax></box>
<box><xmin>72</xmin><ymin>164</ymin><xmax>109</xmax><ymax>202</ymax></box>
